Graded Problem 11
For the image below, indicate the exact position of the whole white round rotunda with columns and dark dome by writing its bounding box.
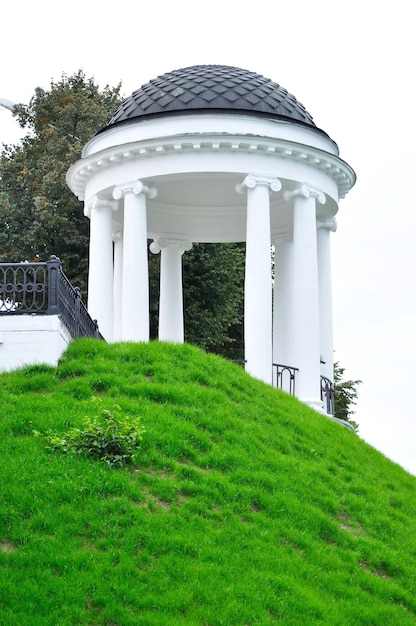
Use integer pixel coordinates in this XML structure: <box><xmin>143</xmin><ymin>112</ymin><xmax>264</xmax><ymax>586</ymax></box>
<box><xmin>67</xmin><ymin>65</ymin><xmax>355</xmax><ymax>412</ymax></box>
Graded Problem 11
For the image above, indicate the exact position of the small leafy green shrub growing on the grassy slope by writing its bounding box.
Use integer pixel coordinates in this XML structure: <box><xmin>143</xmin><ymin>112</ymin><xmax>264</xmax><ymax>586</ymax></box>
<box><xmin>34</xmin><ymin>398</ymin><xmax>146</xmax><ymax>467</ymax></box>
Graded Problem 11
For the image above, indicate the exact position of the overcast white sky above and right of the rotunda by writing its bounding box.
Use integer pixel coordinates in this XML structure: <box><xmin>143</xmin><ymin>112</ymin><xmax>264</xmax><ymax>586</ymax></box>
<box><xmin>0</xmin><ymin>0</ymin><xmax>416</xmax><ymax>474</ymax></box>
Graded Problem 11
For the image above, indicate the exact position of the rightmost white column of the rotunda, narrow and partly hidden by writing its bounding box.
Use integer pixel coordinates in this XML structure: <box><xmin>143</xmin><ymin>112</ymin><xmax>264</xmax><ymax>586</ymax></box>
<box><xmin>317</xmin><ymin>217</ymin><xmax>337</xmax><ymax>382</ymax></box>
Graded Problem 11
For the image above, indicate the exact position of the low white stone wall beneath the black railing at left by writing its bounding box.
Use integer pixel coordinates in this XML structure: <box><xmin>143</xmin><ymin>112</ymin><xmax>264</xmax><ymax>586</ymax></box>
<box><xmin>0</xmin><ymin>315</ymin><xmax>71</xmax><ymax>372</ymax></box>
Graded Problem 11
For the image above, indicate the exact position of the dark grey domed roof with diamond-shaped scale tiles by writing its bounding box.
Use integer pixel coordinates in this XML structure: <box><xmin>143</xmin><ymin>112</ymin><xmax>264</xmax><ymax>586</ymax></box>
<box><xmin>103</xmin><ymin>65</ymin><xmax>316</xmax><ymax>130</ymax></box>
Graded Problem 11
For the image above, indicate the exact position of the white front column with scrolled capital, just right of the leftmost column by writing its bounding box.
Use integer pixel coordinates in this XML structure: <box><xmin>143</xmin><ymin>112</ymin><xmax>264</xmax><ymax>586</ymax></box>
<box><xmin>113</xmin><ymin>181</ymin><xmax>156</xmax><ymax>342</ymax></box>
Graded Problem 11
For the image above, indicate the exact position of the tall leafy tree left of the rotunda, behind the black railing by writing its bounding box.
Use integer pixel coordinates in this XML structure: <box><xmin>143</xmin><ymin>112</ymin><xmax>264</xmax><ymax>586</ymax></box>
<box><xmin>0</xmin><ymin>71</ymin><xmax>122</xmax><ymax>296</ymax></box>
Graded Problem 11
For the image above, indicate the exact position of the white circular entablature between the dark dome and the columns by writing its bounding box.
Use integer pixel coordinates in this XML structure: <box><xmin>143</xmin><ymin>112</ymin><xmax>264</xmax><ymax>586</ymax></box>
<box><xmin>69</xmin><ymin>114</ymin><xmax>355</xmax><ymax>200</ymax></box>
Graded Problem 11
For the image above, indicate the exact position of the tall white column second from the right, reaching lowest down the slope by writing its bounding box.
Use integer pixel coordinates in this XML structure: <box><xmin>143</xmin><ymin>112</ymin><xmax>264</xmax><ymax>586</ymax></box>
<box><xmin>284</xmin><ymin>184</ymin><xmax>325</xmax><ymax>411</ymax></box>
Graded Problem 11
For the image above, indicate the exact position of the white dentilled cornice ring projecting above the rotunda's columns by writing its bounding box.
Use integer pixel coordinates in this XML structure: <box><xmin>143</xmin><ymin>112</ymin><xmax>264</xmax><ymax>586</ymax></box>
<box><xmin>66</xmin><ymin>133</ymin><xmax>356</xmax><ymax>200</ymax></box>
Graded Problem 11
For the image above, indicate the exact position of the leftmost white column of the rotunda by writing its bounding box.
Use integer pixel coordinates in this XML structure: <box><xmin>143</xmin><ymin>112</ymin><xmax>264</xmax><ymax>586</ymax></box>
<box><xmin>85</xmin><ymin>196</ymin><xmax>116</xmax><ymax>341</ymax></box>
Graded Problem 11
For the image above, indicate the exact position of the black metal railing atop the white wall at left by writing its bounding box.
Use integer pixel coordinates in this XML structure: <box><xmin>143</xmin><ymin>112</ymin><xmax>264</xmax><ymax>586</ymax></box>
<box><xmin>0</xmin><ymin>256</ymin><xmax>103</xmax><ymax>339</ymax></box>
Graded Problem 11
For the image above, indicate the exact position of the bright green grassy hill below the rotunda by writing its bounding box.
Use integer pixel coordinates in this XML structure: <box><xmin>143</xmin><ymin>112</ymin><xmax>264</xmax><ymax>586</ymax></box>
<box><xmin>0</xmin><ymin>340</ymin><xmax>416</xmax><ymax>626</ymax></box>
